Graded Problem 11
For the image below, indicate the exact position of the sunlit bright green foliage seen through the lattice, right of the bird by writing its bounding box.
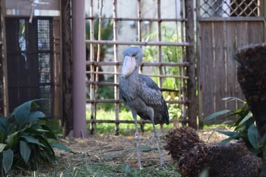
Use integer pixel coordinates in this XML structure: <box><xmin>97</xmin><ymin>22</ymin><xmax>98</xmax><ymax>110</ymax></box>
<box><xmin>143</xmin><ymin>26</ymin><xmax>185</xmax><ymax>119</ymax></box>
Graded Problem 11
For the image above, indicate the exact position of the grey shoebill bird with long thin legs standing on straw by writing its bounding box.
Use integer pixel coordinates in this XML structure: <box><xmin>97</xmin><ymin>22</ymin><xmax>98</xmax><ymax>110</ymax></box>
<box><xmin>119</xmin><ymin>46</ymin><xmax>169</xmax><ymax>169</ymax></box>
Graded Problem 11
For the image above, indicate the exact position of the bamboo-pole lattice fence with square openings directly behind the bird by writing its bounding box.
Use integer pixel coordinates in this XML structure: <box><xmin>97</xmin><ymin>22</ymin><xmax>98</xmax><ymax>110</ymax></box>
<box><xmin>82</xmin><ymin>0</ymin><xmax>196</xmax><ymax>134</ymax></box>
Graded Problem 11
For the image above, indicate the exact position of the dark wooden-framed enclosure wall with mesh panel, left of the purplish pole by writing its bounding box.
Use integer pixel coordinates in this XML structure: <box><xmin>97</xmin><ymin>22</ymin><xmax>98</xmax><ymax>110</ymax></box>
<box><xmin>0</xmin><ymin>0</ymin><xmax>62</xmax><ymax>118</ymax></box>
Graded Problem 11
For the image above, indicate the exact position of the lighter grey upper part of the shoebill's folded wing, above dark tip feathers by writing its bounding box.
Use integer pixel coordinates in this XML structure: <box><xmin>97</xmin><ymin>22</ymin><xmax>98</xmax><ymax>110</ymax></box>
<box><xmin>139</xmin><ymin>75</ymin><xmax>163</xmax><ymax>105</ymax></box>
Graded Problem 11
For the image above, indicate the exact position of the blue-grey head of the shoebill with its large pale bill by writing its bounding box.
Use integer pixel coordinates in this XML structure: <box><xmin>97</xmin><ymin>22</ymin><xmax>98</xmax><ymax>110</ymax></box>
<box><xmin>121</xmin><ymin>47</ymin><xmax>142</xmax><ymax>77</ymax></box>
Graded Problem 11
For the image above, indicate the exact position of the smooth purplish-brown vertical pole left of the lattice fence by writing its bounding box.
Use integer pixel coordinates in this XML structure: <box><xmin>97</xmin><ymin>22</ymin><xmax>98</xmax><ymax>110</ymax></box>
<box><xmin>72</xmin><ymin>0</ymin><xmax>88</xmax><ymax>138</ymax></box>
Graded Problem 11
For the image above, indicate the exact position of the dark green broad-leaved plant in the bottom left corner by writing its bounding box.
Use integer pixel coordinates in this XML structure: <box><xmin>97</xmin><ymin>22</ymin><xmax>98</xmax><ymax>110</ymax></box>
<box><xmin>0</xmin><ymin>100</ymin><xmax>71</xmax><ymax>176</ymax></box>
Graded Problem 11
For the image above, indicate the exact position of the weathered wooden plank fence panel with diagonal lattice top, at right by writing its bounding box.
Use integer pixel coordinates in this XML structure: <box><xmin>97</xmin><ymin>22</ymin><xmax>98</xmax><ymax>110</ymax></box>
<box><xmin>197</xmin><ymin>0</ymin><xmax>265</xmax><ymax>125</ymax></box>
